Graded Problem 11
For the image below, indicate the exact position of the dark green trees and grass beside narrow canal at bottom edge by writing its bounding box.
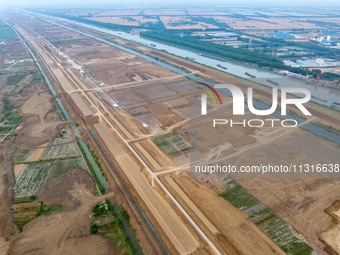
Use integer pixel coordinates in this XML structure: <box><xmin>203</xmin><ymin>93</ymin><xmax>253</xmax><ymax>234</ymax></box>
<box><xmin>90</xmin><ymin>200</ymin><xmax>136</xmax><ymax>254</ymax></box>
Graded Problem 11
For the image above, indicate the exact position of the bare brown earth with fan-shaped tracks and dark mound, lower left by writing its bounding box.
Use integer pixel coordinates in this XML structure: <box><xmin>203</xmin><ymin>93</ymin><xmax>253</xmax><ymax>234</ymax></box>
<box><xmin>9</xmin><ymin>170</ymin><xmax>113</xmax><ymax>255</ymax></box>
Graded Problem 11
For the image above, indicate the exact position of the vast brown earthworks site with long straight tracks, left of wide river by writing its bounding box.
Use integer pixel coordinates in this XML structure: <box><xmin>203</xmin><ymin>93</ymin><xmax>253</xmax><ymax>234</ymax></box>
<box><xmin>0</xmin><ymin>7</ymin><xmax>340</xmax><ymax>255</ymax></box>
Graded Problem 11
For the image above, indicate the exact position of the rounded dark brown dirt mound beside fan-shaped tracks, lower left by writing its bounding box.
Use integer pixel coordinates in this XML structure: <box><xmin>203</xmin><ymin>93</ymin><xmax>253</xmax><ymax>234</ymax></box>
<box><xmin>37</xmin><ymin>169</ymin><xmax>96</xmax><ymax>210</ymax></box>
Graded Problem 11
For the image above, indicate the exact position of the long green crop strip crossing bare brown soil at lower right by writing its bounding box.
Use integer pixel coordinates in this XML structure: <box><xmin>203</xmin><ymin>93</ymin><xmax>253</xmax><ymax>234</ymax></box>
<box><xmin>220</xmin><ymin>180</ymin><xmax>313</xmax><ymax>255</ymax></box>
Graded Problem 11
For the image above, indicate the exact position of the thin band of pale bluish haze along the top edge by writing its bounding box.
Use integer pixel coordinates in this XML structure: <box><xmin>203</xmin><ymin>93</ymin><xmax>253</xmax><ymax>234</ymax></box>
<box><xmin>0</xmin><ymin>0</ymin><xmax>340</xmax><ymax>8</ymax></box>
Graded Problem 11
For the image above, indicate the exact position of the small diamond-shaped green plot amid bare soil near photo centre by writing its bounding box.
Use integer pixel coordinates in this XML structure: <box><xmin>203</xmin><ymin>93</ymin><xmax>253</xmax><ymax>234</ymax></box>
<box><xmin>153</xmin><ymin>132</ymin><xmax>191</xmax><ymax>155</ymax></box>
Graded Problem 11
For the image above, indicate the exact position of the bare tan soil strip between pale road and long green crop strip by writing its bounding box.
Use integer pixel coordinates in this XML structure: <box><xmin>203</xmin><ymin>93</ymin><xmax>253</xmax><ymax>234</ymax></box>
<box><xmin>175</xmin><ymin>176</ymin><xmax>285</xmax><ymax>255</ymax></box>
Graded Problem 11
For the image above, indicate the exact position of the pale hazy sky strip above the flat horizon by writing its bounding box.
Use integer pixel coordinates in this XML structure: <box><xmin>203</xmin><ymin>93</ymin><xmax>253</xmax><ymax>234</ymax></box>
<box><xmin>0</xmin><ymin>0</ymin><xmax>340</xmax><ymax>8</ymax></box>
